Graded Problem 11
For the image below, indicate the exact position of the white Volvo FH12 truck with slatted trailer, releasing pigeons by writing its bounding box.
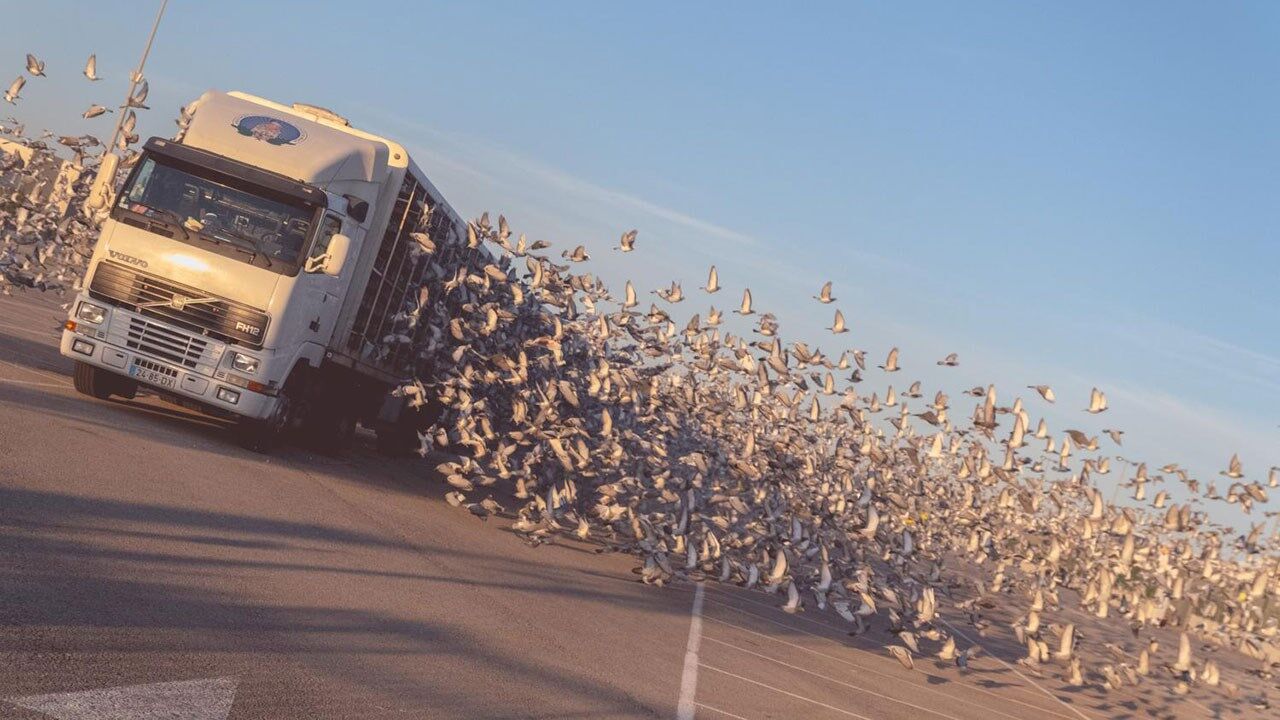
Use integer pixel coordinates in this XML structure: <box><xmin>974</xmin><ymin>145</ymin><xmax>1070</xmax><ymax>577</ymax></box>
<box><xmin>61</xmin><ymin>91</ymin><xmax>471</xmax><ymax>454</ymax></box>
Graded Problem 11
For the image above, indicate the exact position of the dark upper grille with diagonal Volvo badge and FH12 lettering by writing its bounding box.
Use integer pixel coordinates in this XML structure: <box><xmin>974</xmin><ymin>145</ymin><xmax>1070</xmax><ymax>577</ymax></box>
<box><xmin>88</xmin><ymin>261</ymin><xmax>268</xmax><ymax>347</ymax></box>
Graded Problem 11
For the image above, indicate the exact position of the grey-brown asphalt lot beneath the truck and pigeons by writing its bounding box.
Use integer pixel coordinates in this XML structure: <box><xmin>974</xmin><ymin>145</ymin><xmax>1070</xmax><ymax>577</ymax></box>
<box><xmin>0</xmin><ymin>288</ymin><xmax>1251</xmax><ymax>720</ymax></box>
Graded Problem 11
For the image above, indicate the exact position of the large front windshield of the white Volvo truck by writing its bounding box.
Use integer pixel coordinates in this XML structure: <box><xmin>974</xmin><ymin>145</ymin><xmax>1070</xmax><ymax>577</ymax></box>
<box><xmin>116</xmin><ymin>154</ymin><xmax>316</xmax><ymax>273</ymax></box>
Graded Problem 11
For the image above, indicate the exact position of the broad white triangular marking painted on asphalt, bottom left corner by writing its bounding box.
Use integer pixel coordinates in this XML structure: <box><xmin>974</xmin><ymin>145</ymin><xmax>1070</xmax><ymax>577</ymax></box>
<box><xmin>5</xmin><ymin>678</ymin><xmax>236</xmax><ymax>720</ymax></box>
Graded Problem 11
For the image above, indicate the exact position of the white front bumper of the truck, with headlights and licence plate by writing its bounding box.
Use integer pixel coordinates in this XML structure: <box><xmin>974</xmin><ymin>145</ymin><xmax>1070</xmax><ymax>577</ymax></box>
<box><xmin>59</xmin><ymin>301</ymin><xmax>276</xmax><ymax>419</ymax></box>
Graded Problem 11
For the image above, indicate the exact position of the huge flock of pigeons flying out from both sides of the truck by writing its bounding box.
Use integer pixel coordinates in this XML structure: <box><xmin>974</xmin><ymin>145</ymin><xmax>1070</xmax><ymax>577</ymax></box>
<box><xmin>0</xmin><ymin>49</ymin><xmax>1280</xmax><ymax>708</ymax></box>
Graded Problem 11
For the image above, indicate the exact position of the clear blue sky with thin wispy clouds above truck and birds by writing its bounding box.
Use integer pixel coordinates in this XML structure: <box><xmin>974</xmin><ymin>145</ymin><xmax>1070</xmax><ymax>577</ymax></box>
<box><xmin>0</xmin><ymin>0</ymin><xmax>1280</xmax><ymax>520</ymax></box>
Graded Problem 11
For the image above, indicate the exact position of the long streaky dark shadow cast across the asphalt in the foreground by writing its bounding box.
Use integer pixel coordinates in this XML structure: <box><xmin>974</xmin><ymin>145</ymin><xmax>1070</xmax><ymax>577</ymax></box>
<box><xmin>0</xmin><ymin>479</ymin><xmax>687</xmax><ymax>716</ymax></box>
